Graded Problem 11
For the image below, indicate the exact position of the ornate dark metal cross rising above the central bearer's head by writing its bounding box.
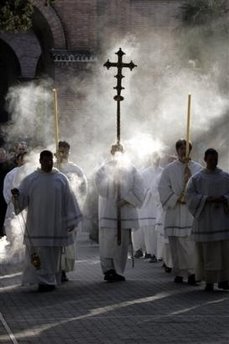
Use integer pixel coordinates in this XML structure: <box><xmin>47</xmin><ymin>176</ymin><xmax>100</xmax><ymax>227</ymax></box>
<box><xmin>104</xmin><ymin>48</ymin><xmax>137</xmax><ymax>144</ymax></box>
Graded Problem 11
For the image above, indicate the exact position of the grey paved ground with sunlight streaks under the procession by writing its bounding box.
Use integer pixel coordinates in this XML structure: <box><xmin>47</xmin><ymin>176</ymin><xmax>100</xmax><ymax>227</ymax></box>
<box><xmin>0</xmin><ymin>233</ymin><xmax>229</xmax><ymax>344</ymax></box>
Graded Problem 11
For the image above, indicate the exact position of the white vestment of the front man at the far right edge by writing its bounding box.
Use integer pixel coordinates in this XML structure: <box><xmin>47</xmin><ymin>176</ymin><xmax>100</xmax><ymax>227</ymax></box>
<box><xmin>185</xmin><ymin>168</ymin><xmax>229</xmax><ymax>283</ymax></box>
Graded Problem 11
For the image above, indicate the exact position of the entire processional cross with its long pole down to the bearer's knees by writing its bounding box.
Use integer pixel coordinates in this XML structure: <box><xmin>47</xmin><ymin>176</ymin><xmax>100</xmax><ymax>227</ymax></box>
<box><xmin>104</xmin><ymin>48</ymin><xmax>137</xmax><ymax>245</ymax></box>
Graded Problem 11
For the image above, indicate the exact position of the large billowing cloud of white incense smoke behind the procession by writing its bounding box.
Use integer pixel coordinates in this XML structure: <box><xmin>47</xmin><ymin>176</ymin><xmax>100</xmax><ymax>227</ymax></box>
<box><xmin>0</xmin><ymin>6</ymin><xmax>229</xmax><ymax>268</ymax></box>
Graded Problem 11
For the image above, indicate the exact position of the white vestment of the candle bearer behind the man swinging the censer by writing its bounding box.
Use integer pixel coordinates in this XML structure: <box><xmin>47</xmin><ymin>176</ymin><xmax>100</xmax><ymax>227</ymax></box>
<box><xmin>58</xmin><ymin>161</ymin><xmax>88</xmax><ymax>272</ymax></box>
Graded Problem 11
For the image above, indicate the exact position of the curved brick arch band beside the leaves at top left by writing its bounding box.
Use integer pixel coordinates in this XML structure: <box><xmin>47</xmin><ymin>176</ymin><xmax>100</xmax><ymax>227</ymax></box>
<box><xmin>34</xmin><ymin>0</ymin><xmax>67</xmax><ymax>49</ymax></box>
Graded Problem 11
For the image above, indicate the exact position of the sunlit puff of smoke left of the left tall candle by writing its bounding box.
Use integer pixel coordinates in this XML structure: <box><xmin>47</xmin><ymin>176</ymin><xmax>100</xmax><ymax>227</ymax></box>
<box><xmin>6</xmin><ymin>80</ymin><xmax>54</xmax><ymax>147</ymax></box>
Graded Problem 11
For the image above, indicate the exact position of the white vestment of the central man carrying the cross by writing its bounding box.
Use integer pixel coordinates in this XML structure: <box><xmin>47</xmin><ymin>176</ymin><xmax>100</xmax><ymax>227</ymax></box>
<box><xmin>95</xmin><ymin>160</ymin><xmax>145</xmax><ymax>272</ymax></box>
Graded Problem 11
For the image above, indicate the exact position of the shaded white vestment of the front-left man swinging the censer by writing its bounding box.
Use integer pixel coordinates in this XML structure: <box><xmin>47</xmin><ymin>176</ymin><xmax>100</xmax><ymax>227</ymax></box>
<box><xmin>14</xmin><ymin>169</ymin><xmax>82</xmax><ymax>284</ymax></box>
